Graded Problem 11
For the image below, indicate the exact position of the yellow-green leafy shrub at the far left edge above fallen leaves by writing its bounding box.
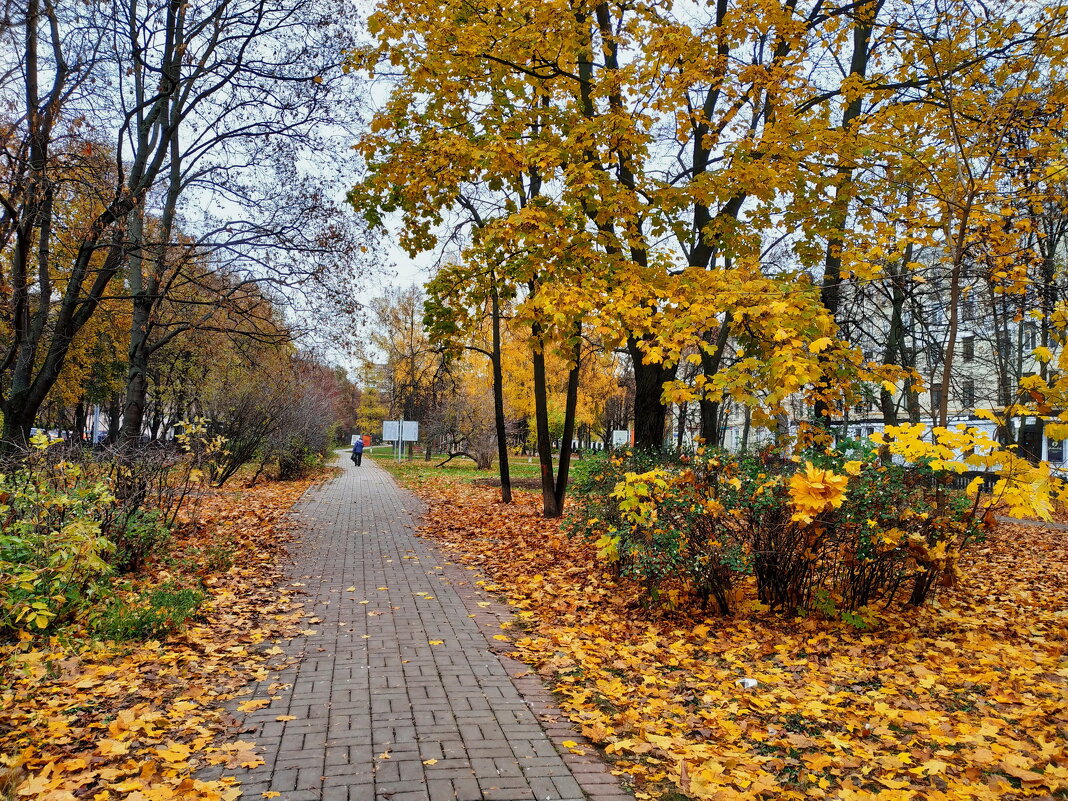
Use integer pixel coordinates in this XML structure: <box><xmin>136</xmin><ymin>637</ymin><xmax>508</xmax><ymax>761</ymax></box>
<box><xmin>0</xmin><ymin>437</ymin><xmax>203</xmax><ymax>638</ymax></box>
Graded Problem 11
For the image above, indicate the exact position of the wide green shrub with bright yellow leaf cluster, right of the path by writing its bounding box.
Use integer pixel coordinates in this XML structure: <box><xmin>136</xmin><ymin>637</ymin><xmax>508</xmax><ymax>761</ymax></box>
<box><xmin>570</xmin><ymin>443</ymin><xmax>983</xmax><ymax>625</ymax></box>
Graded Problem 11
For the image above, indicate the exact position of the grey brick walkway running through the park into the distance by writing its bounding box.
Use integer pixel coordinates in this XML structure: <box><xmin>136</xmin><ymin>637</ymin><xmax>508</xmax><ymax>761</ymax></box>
<box><xmin>218</xmin><ymin>459</ymin><xmax>631</xmax><ymax>801</ymax></box>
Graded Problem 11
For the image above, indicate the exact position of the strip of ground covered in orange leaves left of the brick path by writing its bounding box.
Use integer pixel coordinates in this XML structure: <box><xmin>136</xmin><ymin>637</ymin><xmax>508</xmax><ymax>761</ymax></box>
<box><xmin>0</xmin><ymin>481</ymin><xmax>320</xmax><ymax>801</ymax></box>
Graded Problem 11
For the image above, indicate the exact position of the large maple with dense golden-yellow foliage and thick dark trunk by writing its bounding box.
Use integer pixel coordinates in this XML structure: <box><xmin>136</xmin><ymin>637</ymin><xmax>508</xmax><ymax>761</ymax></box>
<box><xmin>354</xmin><ymin>2</ymin><xmax>909</xmax><ymax>469</ymax></box>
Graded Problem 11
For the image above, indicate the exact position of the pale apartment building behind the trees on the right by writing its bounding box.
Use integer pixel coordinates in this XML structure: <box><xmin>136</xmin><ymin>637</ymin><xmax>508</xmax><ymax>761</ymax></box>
<box><xmin>704</xmin><ymin>254</ymin><xmax>1066</xmax><ymax>467</ymax></box>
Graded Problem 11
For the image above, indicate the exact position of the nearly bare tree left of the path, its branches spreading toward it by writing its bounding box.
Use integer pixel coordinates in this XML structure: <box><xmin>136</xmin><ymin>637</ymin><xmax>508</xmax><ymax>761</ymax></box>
<box><xmin>114</xmin><ymin>0</ymin><xmax>361</xmax><ymax>442</ymax></box>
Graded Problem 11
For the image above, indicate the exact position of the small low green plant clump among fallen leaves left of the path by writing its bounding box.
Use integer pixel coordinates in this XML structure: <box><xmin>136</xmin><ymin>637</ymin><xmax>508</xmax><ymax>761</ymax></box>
<box><xmin>92</xmin><ymin>582</ymin><xmax>204</xmax><ymax>640</ymax></box>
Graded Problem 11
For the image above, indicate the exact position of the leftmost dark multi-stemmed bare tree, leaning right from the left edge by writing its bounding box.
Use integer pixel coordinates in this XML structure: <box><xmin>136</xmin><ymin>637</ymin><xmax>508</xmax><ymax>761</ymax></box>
<box><xmin>0</xmin><ymin>0</ymin><xmax>195</xmax><ymax>446</ymax></box>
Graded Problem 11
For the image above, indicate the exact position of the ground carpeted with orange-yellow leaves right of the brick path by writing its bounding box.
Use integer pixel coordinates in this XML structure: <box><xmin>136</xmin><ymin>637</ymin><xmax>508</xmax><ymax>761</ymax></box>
<box><xmin>403</xmin><ymin>481</ymin><xmax>1068</xmax><ymax>801</ymax></box>
